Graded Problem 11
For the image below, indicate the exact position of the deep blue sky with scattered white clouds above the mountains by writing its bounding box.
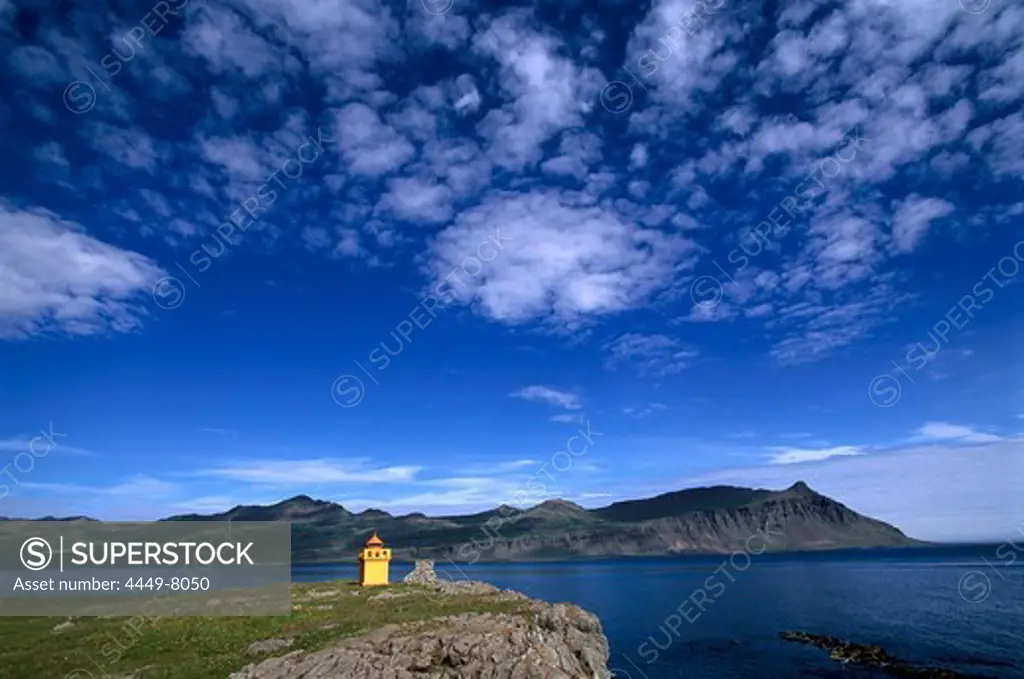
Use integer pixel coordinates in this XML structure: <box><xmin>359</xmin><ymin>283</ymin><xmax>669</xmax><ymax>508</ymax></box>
<box><xmin>0</xmin><ymin>0</ymin><xmax>1024</xmax><ymax>540</ymax></box>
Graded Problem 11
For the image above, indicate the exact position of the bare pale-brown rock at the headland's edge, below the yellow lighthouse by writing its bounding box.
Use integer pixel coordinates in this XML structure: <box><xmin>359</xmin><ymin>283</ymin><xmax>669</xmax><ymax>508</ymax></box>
<box><xmin>229</xmin><ymin>598</ymin><xmax>611</xmax><ymax>679</ymax></box>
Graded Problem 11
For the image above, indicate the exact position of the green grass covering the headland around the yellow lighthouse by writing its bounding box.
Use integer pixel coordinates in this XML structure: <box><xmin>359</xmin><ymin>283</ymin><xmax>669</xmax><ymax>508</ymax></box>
<box><xmin>0</xmin><ymin>581</ymin><xmax>527</xmax><ymax>679</ymax></box>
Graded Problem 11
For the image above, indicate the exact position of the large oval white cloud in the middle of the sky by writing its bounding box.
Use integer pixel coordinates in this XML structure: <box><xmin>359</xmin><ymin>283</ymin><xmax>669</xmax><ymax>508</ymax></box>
<box><xmin>427</xmin><ymin>192</ymin><xmax>695</xmax><ymax>329</ymax></box>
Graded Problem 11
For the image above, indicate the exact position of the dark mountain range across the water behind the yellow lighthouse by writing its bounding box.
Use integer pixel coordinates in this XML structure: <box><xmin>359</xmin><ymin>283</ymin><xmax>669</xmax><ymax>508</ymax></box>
<box><xmin>164</xmin><ymin>481</ymin><xmax>925</xmax><ymax>562</ymax></box>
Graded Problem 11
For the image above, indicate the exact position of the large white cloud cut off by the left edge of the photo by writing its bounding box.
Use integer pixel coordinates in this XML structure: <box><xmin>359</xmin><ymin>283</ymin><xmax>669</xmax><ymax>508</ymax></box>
<box><xmin>0</xmin><ymin>203</ymin><xmax>164</xmax><ymax>339</ymax></box>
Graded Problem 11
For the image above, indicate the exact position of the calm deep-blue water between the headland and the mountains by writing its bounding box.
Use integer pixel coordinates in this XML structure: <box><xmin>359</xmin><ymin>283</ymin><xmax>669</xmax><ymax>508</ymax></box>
<box><xmin>294</xmin><ymin>546</ymin><xmax>1024</xmax><ymax>679</ymax></box>
